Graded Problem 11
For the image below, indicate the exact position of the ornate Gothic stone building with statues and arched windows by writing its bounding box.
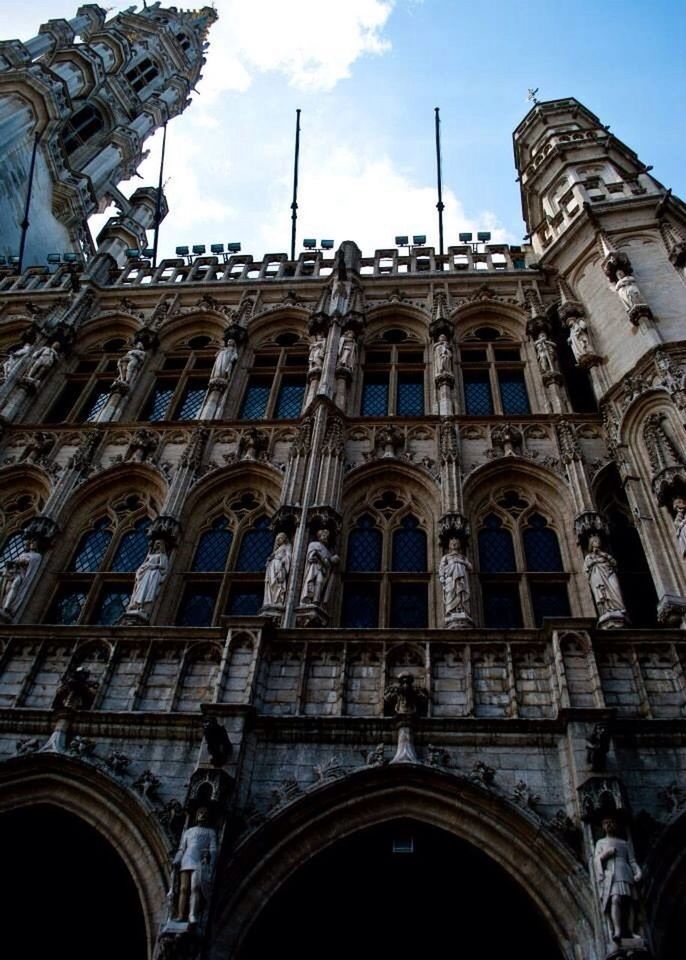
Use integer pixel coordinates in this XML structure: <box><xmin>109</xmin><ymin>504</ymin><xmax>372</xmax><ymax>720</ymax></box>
<box><xmin>0</xmin><ymin>5</ymin><xmax>686</xmax><ymax>960</ymax></box>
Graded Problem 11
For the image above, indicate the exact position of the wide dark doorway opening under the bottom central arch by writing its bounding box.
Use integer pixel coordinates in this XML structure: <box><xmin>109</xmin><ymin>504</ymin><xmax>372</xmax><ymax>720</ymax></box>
<box><xmin>239</xmin><ymin>819</ymin><xmax>561</xmax><ymax>960</ymax></box>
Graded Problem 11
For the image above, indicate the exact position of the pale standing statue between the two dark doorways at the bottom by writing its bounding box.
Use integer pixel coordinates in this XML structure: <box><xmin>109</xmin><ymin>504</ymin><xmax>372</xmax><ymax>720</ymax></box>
<box><xmin>170</xmin><ymin>807</ymin><xmax>217</xmax><ymax>924</ymax></box>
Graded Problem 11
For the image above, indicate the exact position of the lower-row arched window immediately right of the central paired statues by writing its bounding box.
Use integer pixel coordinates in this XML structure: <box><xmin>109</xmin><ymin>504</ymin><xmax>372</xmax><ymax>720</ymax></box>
<box><xmin>341</xmin><ymin>498</ymin><xmax>429</xmax><ymax>628</ymax></box>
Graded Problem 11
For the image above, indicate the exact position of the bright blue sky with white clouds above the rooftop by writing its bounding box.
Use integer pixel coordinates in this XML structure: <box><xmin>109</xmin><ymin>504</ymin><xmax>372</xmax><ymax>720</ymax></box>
<box><xmin>0</xmin><ymin>0</ymin><xmax>686</xmax><ymax>258</ymax></box>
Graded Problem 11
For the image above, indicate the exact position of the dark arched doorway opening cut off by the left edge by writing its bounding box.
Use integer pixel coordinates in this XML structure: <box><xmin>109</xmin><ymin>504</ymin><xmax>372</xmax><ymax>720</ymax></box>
<box><xmin>0</xmin><ymin>803</ymin><xmax>148</xmax><ymax>960</ymax></box>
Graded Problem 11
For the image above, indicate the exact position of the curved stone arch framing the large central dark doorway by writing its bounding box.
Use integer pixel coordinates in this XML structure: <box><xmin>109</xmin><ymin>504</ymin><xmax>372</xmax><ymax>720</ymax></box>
<box><xmin>209</xmin><ymin>764</ymin><xmax>602</xmax><ymax>960</ymax></box>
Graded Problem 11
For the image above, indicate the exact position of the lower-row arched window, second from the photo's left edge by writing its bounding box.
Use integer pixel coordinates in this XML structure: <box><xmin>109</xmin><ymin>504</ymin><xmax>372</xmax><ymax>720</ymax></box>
<box><xmin>46</xmin><ymin>495</ymin><xmax>150</xmax><ymax>625</ymax></box>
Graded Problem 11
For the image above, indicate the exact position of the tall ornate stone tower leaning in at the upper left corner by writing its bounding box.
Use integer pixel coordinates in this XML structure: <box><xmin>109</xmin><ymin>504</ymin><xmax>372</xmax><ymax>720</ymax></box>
<box><xmin>0</xmin><ymin>3</ymin><xmax>216</xmax><ymax>265</ymax></box>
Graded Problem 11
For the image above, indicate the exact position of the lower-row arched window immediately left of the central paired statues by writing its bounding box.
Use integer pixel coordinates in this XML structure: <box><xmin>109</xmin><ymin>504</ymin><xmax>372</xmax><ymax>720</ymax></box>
<box><xmin>176</xmin><ymin>506</ymin><xmax>274</xmax><ymax>627</ymax></box>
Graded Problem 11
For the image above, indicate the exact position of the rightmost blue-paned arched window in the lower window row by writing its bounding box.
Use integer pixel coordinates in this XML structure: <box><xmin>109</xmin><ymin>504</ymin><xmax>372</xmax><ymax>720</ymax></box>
<box><xmin>477</xmin><ymin>491</ymin><xmax>570</xmax><ymax>629</ymax></box>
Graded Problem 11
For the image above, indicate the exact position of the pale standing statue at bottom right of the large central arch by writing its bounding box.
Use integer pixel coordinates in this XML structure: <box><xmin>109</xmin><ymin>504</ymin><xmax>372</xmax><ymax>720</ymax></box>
<box><xmin>593</xmin><ymin>818</ymin><xmax>641</xmax><ymax>944</ymax></box>
